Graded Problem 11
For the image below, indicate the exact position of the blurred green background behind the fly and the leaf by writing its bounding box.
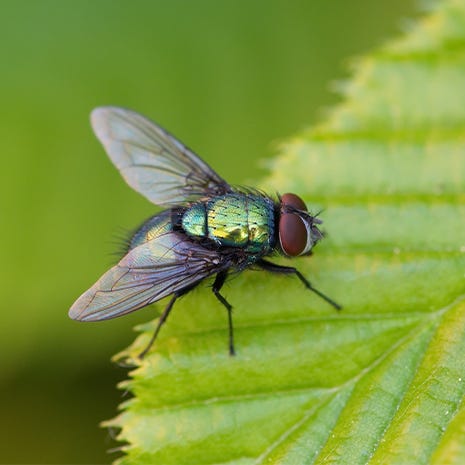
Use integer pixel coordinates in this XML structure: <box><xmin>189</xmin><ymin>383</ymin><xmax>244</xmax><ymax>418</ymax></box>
<box><xmin>0</xmin><ymin>0</ymin><xmax>417</xmax><ymax>464</ymax></box>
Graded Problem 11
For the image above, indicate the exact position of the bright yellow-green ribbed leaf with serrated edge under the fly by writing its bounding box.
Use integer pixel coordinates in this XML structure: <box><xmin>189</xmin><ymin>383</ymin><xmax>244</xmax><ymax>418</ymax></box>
<box><xmin>109</xmin><ymin>1</ymin><xmax>465</xmax><ymax>465</ymax></box>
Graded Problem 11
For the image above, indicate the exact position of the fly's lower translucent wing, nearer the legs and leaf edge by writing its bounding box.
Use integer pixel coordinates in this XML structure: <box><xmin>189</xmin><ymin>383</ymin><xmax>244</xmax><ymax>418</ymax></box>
<box><xmin>69</xmin><ymin>232</ymin><xmax>227</xmax><ymax>321</ymax></box>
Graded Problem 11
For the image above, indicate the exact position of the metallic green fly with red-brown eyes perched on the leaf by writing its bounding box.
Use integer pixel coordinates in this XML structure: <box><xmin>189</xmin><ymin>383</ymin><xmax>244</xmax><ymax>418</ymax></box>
<box><xmin>69</xmin><ymin>107</ymin><xmax>341</xmax><ymax>357</ymax></box>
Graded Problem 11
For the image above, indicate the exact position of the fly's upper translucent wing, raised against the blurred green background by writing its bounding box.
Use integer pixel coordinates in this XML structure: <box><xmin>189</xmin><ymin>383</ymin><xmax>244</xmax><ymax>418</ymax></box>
<box><xmin>91</xmin><ymin>107</ymin><xmax>232</xmax><ymax>206</ymax></box>
